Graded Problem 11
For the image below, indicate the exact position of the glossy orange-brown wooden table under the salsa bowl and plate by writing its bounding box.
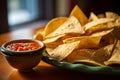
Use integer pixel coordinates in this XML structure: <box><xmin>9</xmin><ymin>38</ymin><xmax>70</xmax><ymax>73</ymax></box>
<box><xmin>0</xmin><ymin>28</ymin><xmax>119</xmax><ymax>80</ymax></box>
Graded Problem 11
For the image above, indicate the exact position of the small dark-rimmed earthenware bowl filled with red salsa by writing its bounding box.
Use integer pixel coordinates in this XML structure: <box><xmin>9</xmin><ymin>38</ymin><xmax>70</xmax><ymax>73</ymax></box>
<box><xmin>0</xmin><ymin>39</ymin><xmax>45</xmax><ymax>72</ymax></box>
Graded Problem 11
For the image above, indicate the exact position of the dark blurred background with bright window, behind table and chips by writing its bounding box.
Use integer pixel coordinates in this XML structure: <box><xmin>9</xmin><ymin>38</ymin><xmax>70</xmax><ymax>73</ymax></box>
<box><xmin>0</xmin><ymin>0</ymin><xmax>120</xmax><ymax>34</ymax></box>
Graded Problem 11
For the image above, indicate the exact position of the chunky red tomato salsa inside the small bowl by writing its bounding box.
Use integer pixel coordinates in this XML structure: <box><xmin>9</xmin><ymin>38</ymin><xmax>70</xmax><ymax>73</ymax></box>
<box><xmin>6</xmin><ymin>42</ymin><xmax>41</xmax><ymax>52</ymax></box>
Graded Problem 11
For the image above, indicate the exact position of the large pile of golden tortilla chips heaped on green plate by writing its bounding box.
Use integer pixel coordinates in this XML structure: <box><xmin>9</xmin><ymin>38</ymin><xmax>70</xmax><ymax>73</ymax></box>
<box><xmin>34</xmin><ymin>5</ymin><xmax>120</xmax><ymax>65</ymax></box>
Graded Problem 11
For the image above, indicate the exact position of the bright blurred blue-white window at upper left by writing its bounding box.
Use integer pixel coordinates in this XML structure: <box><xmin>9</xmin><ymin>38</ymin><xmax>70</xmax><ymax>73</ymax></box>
<box><xmin>8</xmin><ymin>0</ymin><xmax>40</xmax><ymax>26</ymax></box>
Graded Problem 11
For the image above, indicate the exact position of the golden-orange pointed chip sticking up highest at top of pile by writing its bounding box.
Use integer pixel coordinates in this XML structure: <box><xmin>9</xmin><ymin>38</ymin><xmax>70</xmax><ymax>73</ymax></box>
<box><xmin>70</xmin><ymin>5</ymin><xmax>88</xmax><ymax>26</ymax></box>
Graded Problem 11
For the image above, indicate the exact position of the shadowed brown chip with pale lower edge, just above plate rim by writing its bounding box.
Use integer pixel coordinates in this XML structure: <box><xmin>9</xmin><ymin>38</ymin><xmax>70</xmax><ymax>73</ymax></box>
<box><xmin>64</xmin><ymin>49</ymin><xmax>103</xmax><ymax>66</ymax></box>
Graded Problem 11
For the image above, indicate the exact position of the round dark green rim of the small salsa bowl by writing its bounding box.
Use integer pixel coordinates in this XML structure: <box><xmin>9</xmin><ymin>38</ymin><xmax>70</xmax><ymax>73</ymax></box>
<box><xmin>0</xmin><ymin>39</ymin><xmax>46</xmax><ymax>56</ymax></box>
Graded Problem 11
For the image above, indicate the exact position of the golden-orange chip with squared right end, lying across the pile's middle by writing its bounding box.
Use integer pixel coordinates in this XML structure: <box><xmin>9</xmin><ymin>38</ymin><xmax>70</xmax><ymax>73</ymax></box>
<box><xmin>63</xmin><ymin>36</ymin><xmax>101</xmax><ymax>49</ymax></box>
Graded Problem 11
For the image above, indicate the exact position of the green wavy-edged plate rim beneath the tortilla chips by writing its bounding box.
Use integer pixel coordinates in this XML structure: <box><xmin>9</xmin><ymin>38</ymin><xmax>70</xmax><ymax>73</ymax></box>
<box><xmin>42</xmin><ymin>52</ymin><xmax>120</xmax><ymax>74</ymax></box>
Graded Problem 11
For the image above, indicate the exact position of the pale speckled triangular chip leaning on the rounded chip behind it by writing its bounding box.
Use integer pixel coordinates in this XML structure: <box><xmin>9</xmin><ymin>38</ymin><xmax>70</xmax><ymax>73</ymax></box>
<box><xmin>46</xmin><ymin>16</ymin><xmax>85</xmax><ymax>38</ymax></box>
